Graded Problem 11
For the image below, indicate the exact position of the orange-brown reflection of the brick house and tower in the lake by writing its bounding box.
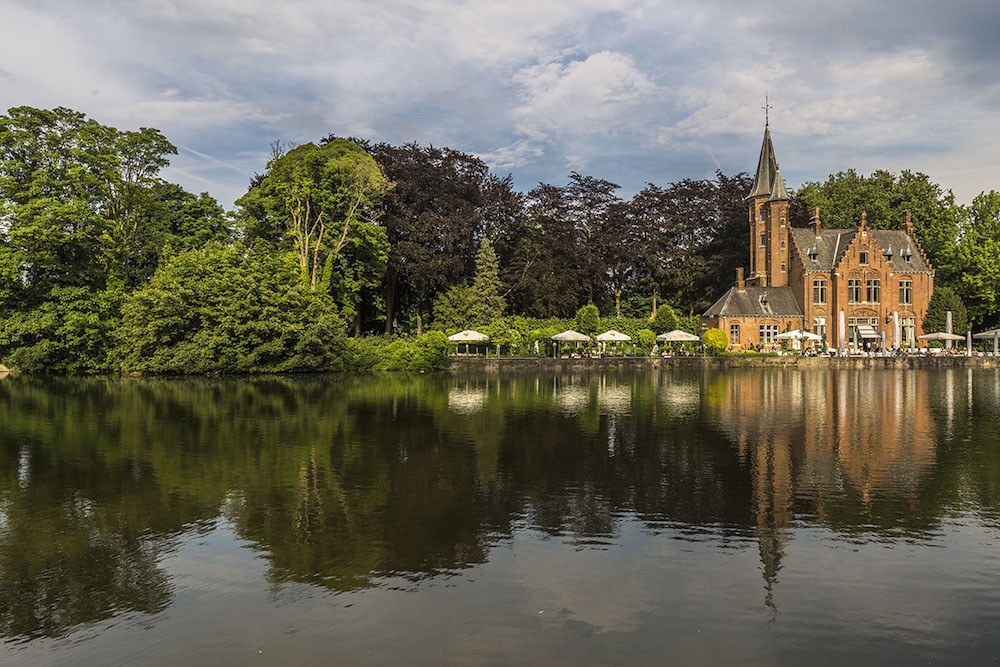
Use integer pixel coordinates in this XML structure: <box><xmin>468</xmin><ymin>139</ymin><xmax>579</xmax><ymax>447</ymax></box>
<box><xmin>713</xmin><ymin>369</ymin><xmax>936</xmax><ymax>606</ymax></box>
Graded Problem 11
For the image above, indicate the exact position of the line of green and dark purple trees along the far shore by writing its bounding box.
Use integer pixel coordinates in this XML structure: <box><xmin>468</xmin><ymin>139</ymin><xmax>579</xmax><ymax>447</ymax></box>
<box><xmin>0</xmin><ymin>107</ymin><xmax>1000</xmax><ymax>373</ymax></box>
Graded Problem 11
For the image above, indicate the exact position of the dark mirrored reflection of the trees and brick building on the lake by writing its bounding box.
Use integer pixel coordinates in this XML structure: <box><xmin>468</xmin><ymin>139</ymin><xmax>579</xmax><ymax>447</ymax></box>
<box><xmin>0</xmin><ymin>368</ymin><xmax>1000</xmax><ymax>640</ymax></box>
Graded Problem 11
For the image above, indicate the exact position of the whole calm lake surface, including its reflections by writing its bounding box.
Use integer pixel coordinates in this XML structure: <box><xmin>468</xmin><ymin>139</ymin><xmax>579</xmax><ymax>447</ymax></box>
<box><xmin>0</xmin><ymin>368</ymin><xmax>1000</xmax><ymax>665</ymax></box>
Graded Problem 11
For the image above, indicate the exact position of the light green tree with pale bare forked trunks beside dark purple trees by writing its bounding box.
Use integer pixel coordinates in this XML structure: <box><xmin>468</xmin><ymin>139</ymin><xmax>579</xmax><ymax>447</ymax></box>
<box><xmin>236</xmin><ymin>139</ymin><xmax>389</xmax><ymax>290</ymax></box>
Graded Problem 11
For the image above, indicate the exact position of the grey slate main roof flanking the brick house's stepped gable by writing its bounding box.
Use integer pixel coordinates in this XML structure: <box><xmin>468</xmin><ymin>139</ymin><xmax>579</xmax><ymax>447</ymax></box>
<box><xmin>792</xmin><ymin>227</ymin><xmax>931</xmax><ymax>273</ymax></box>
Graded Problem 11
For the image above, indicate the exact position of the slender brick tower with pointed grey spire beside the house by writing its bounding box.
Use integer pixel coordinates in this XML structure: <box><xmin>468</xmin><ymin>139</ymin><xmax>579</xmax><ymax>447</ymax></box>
<box><xmin>747</xmin><ymin>118</ymin><xmax>791</xmax><ymax>287</ymax></box>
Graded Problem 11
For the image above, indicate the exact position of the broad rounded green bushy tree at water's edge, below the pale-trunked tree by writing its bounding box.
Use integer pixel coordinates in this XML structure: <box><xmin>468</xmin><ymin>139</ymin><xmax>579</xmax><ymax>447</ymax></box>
<box><xmin>121</xmin><ymin>243</ymin><xmax>345</xmax><ymax>373</ymax></box>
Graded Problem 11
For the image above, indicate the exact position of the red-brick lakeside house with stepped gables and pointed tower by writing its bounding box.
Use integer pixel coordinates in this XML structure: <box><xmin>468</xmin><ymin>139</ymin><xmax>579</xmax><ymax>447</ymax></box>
<box><xmin>702</xmin><ymin>124</ymin><xmax>934</xmax><ymax>350</ymax></box>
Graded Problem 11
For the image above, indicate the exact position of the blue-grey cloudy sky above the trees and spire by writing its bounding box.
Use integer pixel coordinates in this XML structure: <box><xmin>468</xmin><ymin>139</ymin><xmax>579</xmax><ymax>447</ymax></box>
<box><xmin>0</xmin><ymin>0</ymin><xmax>1000</xmax><ymax>207</ymax></box>
